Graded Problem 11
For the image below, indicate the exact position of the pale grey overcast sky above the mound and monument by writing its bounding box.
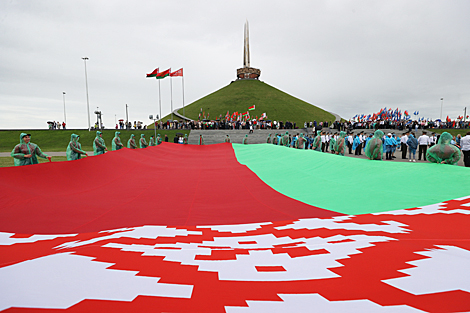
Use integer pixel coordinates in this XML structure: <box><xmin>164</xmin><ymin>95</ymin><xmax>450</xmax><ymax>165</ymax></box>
<box><xmin>0</xmin><ymin>0</ymin><xmax>470</xmax><ymax>129</ymax></box>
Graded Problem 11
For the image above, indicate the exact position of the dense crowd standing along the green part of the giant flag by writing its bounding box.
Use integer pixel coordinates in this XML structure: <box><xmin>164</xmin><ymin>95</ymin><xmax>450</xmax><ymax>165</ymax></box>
<box><xmin>266</xmin><ymin>129</ymin><xmax>470</xmax><ymax>167</ymax></box>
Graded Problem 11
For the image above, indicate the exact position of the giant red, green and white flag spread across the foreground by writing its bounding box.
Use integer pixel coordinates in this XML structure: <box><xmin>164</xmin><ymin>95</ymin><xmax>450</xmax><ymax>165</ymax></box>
<box><xmin>0</xmin><ymin>143</ymin><xmax>470</xmax><ymax>313</ymax></box>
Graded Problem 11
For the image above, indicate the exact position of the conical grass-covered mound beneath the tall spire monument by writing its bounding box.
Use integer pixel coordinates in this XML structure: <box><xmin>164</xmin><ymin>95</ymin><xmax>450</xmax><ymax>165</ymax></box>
<box><xmin>171</xmin><ymin>80</ymin><xmax>335</xmax><ymax>126</ymax></box>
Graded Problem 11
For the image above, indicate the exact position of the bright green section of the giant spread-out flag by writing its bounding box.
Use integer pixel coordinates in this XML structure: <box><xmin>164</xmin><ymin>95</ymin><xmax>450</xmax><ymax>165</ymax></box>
<box><xmin>232</xmin><ymin>144</ymin><xmax>470</xmax><ymax>215</ymax></box>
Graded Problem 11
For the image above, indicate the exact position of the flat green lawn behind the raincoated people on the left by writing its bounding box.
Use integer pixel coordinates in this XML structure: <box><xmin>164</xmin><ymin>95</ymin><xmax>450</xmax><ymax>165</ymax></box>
<box><xmin>0</xmin><ymin>129</ymin><xmax>189</xmax><ymax>152</ymax></box>
